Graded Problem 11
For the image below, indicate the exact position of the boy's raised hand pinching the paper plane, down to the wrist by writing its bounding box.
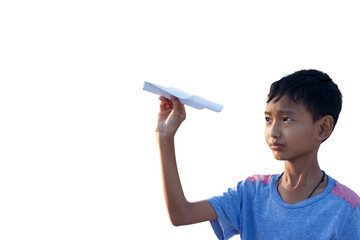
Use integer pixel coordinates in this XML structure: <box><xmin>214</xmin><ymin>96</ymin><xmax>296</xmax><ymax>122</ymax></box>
<box><xmin>156</xmin><ymin>96</ymin><xmax>186</xmax><ymax>137</ymax></box>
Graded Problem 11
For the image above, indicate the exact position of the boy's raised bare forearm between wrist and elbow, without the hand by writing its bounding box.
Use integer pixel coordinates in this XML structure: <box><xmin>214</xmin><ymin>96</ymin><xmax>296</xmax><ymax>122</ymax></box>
<box><xmin>157</xmin><ymin>133</ymin><xmax>189</xmax><ymax>225</ymax></box>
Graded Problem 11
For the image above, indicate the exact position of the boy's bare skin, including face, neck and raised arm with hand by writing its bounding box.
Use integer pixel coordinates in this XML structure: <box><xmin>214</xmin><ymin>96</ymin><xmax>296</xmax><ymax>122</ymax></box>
<box><xmin>156</xmin><ymin>94</ymin><xmax>334</xmax><ymax>226</ymax></box>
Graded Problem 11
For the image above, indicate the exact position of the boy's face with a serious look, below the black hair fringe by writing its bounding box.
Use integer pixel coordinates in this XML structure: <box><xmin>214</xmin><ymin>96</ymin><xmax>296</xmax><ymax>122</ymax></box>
<box><xmin>265</xmin><ymin>96</ymin><xmax>321</xmax><ymax>161</ymax></box>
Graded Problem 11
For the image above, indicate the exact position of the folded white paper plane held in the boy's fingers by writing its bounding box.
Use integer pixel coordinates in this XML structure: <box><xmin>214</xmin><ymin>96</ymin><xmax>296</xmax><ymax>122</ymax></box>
<box><xmin>143</xmin><ymin>82</ymin><xmax>223</xmax><ymax>112</ymax></box>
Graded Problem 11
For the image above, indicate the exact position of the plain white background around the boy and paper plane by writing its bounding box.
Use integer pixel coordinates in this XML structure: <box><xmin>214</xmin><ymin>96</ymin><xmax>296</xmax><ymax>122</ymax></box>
<box><xmin>0</xmin><ymin>0</ymin><xmax>360</xmax><ymax>239</ymax></box>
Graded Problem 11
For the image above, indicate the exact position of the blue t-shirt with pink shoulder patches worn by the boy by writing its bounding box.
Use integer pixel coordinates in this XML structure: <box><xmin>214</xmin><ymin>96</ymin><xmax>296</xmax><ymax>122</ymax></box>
<box><xmin>209</xmin><ymin>175</ymin><xmax>360</xmax><ymax>240</ymax></box>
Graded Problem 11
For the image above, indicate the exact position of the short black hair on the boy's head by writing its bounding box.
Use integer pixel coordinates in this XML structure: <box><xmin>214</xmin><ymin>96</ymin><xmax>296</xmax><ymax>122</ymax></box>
<box><xmin>267</xmin><ymin>69</ymin><xmax>342</xmax><ymax>127</ymax></box>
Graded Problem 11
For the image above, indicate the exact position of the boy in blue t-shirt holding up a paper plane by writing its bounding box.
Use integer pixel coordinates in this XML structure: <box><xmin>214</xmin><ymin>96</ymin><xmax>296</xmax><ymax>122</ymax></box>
<box><xmin>156</xmin><ymin>70</ymin><xmax>360</xmax><ymax>240</ymax></box>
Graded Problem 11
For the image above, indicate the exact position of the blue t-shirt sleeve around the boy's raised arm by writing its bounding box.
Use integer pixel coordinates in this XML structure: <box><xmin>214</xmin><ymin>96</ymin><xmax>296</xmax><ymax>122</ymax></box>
<box><xmin>208</xmin><ymin>182</ymin><xmax>243</xmax><ymax>240</ymax></box>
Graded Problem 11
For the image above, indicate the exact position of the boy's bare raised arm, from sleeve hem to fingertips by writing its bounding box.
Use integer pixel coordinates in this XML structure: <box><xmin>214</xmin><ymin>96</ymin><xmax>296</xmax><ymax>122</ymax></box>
<box><xmin>156</xmin><ymin>97</ymin><xmax>217</xmax><ymax>226</ymax></box>
